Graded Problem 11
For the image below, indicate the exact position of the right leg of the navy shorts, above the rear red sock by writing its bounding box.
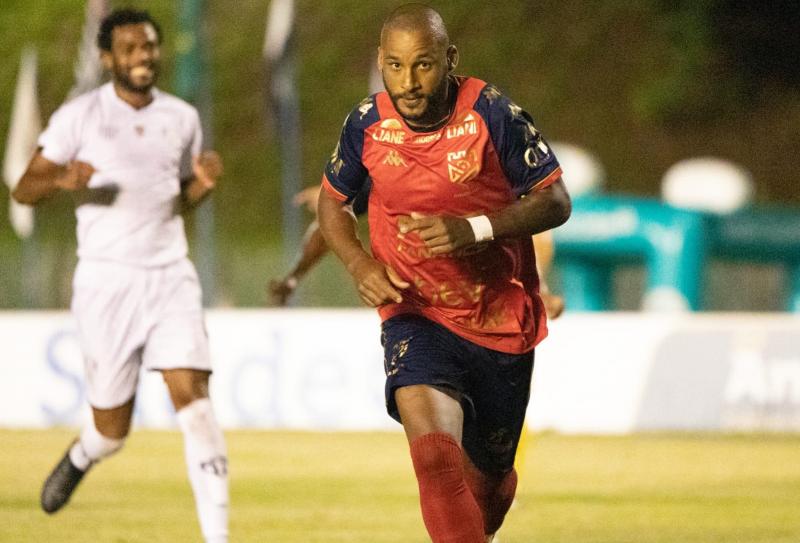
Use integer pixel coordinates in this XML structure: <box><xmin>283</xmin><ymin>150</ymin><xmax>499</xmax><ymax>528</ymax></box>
<box><xmin>462</xmin><ymin>349</ymin><xmax>533</xmax><ymax>473</ymax></box>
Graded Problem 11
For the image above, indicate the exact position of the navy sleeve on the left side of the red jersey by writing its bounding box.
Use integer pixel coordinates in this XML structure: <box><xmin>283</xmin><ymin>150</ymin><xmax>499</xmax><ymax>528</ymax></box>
<box><xmin>322</xmin><ymin>96</ymin><xmax>378</xmax><ymax>204</ymax></box>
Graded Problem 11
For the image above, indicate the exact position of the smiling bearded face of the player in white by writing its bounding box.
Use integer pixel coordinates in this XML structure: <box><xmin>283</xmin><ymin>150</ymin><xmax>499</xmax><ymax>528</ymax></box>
<box><xmin>102</xmin><ymin>23</ymin><xmax>161</xmax><ymax>93</ymax></box>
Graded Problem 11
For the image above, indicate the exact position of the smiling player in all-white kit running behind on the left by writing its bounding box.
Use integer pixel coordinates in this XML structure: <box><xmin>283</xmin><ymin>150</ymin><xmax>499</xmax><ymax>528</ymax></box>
<box><xmin>13</xmin><ymin>10</ymin><xmax>228</xmax><ymax>543</ymax></box>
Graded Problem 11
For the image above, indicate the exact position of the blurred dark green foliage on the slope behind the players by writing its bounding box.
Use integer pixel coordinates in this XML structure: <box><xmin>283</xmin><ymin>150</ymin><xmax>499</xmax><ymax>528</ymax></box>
<box><xmin>0</xmin><ymin>0</ymin><xmax>800</xmax><ymax>307</ymax></box>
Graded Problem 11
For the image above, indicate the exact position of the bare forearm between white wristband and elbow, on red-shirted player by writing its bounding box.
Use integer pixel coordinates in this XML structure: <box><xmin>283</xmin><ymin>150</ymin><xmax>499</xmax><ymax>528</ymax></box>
<box><xmin>489</xmin><ymin>180</ymin><xmax>572</xmax><ymax>238</ymax></box>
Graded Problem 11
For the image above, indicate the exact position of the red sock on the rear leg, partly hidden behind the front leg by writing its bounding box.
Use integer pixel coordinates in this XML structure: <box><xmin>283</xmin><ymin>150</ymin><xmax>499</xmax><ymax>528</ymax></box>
<box><xmin>464</xmin><ymin>455</ymin><xmax>517</xmax><ymax>534</ymax></box>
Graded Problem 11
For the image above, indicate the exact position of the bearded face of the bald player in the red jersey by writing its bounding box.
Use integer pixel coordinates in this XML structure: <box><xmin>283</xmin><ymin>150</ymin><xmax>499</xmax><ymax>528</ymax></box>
<box><xmin>378</xmin><ymin>29</ymin><xmax>455</xmax><ymax>125</ymax></box>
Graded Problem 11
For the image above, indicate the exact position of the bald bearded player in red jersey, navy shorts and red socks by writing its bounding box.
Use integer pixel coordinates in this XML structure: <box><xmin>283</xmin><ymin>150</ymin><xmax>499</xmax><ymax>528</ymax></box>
<box><xmin>318</xmin><ymin>4</ymin><xmax>570</xmax><ymax>543</ymax></box>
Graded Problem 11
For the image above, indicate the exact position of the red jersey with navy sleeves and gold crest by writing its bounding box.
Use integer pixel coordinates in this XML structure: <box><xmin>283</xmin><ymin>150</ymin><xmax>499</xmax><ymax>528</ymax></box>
<box><xmin>322</xmin><ymin>78</ymin><xmax>561</xmax><ymax>353</ymax></box>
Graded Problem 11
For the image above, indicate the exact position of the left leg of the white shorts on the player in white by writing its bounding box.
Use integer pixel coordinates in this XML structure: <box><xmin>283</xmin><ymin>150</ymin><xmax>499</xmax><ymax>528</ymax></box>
<box><xmin>72</xmin><ymin>261</ymin><xmax>147</xmax><ymax>409</ymax></box>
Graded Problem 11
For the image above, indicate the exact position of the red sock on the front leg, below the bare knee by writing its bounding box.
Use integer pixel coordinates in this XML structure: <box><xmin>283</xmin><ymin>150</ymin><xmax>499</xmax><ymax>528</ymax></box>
<box><xmin>411</xmin><ymin>433</ymin><xmax>484</xmax><ymax>543</ymax></box>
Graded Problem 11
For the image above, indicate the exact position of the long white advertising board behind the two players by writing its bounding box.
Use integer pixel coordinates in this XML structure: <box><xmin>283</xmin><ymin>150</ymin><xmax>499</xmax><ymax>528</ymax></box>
<box><xmin>0</xmin><ymin>309</ymin><xmax>800</xmax><ymax>433</ymax></box>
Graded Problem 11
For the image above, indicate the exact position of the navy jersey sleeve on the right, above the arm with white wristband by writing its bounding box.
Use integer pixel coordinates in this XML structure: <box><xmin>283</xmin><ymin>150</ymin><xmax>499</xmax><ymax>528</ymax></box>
<box><xmin>475</xmin><ymin>85</ymin><xmax>561</xmax><ymax>196</ymax></box>
